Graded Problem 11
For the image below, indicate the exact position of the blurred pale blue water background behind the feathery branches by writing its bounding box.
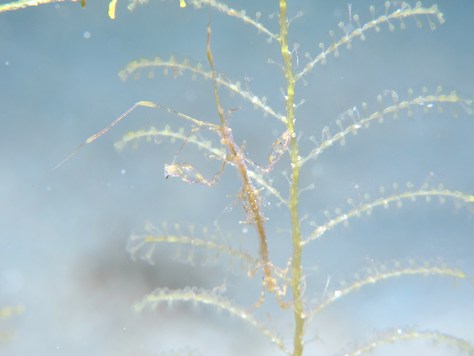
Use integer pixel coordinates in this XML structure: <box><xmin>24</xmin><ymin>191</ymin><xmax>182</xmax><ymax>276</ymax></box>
<box><xmin>0</xmin><ymin>0</ymin><xmax>474</xmax><ymax>356</ymax></box>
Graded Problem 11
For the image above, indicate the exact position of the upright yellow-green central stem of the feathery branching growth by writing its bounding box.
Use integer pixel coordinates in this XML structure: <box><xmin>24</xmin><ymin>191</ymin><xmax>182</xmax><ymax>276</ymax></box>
<box><xmin>279</xmin><ymin>0</ymin><xmax>305</xmax><ymax>356</ymax></box>
